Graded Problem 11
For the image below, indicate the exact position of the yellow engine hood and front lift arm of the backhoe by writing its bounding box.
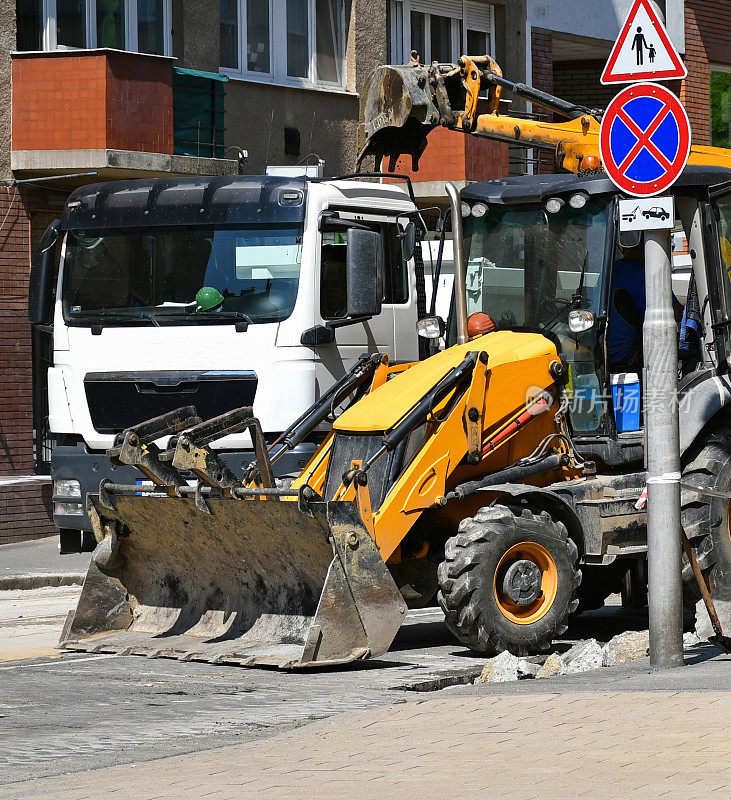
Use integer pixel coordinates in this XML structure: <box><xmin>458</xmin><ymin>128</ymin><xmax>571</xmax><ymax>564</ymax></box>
<box><xmin>304</xmin><ymin>331</ymin><xmax>571</xmax><ymax>564</ymax></box>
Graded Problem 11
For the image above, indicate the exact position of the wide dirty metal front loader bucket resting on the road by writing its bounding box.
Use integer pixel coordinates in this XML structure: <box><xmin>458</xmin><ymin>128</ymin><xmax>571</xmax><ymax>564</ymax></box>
<box><xmin>60</xmin><ymin>494</ymin><xmax>406</xmax><ymax>668</ymax></box>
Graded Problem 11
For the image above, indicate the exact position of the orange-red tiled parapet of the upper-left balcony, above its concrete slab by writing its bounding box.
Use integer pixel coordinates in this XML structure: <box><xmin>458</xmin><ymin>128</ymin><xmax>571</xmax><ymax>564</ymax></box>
<box><xmin>12</xmin><ymin>50</ymin><xmax>173</xmax><ymax>153</ymax></box>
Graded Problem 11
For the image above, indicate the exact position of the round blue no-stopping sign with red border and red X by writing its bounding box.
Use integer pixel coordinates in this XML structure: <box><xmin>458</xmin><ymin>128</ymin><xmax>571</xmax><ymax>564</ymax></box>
<box><xmin>599</xmin><ymin>83</ymin><xmax>691</xmax><ymax>197</ymax></box>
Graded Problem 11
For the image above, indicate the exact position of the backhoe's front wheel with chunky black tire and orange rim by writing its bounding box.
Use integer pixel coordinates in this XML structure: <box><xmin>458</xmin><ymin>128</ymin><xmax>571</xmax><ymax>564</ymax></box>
<box><xmin>437</xmin><ymin>505</ymin><xmax>581</xmax><ymax>656</ymax></box>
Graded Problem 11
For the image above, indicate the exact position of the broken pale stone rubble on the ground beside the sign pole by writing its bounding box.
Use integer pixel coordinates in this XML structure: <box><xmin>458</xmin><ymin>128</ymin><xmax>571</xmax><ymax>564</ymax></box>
<box><xmin>475</xmin><ymin>631</ymin><xmax>700</xmax><ymax>683</ymax></box>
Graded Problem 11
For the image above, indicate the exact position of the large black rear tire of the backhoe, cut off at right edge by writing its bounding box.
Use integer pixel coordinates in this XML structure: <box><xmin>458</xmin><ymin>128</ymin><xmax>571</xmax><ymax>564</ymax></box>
<box><xmin>681</xmin><ymin>425</ymin><xmax>731</xmax><ymax>611</ymax></box>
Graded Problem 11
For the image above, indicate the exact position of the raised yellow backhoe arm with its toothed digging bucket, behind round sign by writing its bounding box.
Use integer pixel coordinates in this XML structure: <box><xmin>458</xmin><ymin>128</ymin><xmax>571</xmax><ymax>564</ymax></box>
<box><xmin>358</xmin><ymin>56</ymin><xmax>731</xmax><ymax>173</ymax></box>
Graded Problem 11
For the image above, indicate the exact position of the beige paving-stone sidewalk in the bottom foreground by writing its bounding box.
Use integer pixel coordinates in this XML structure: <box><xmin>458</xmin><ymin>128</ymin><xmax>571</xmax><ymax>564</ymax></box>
<box><xmin>0</xmin><ymin>691</ymin><xmax>731</xmax><ymax>800</ymax></box>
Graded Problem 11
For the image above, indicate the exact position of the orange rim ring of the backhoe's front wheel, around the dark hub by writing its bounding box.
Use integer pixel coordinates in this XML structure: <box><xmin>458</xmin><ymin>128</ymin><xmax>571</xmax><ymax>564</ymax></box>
<box><xmin>493</xmin><ymin>542</ymin><xmax>558</xmax><ymax>625</ymax></box>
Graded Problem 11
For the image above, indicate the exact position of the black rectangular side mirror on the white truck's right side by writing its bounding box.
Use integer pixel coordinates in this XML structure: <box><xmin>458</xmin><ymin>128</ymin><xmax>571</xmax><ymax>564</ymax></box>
<box><xmin>345</xmin><ymin>228</ymin><xmax>383</xmax><ymax>317</ymax></box>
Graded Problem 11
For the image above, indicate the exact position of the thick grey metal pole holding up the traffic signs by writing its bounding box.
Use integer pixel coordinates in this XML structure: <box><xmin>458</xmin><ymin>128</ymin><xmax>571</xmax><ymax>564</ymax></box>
<box><xmin>643</xmin><ymin>230</ymin><xmax>683</xmax><ymax>669</ymax></box>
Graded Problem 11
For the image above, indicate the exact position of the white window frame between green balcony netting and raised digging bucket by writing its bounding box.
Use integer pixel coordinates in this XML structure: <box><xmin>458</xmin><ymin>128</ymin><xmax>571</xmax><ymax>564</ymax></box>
<box><xmin>219</xmin><ymin>0</ymin><xmax>347</xmax><ymax>92</ymax></box>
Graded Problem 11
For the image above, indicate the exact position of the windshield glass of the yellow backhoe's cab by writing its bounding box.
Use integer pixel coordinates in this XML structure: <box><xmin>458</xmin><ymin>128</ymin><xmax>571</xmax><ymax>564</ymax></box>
<box><xmin>465</xmin><ymin>200</ymin><xmax>610</xmax><ymax>334</ymax></box>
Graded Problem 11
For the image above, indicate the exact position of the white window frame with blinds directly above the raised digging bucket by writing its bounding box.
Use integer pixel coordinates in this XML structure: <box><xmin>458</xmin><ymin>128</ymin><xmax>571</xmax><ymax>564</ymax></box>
<box><xmin>389</xmin><ymin>0</ymin><xmax>495</xmax><ymax>64</ymax></box>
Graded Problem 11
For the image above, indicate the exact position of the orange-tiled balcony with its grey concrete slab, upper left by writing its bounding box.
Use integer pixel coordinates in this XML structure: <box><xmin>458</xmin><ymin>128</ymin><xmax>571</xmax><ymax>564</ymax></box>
<box><xmin>11</xmin><ymin>49</ymin><xmax>238</xmax><ymax>180</ymax></box>
